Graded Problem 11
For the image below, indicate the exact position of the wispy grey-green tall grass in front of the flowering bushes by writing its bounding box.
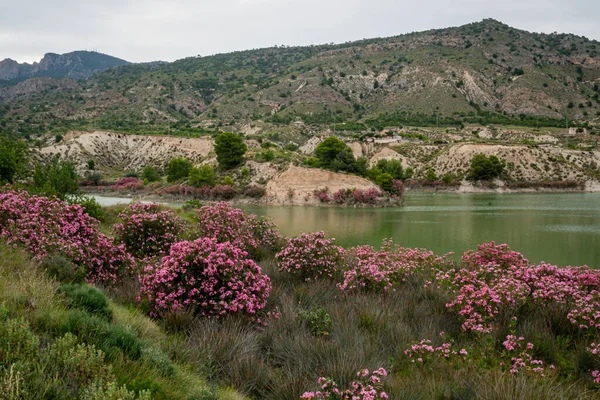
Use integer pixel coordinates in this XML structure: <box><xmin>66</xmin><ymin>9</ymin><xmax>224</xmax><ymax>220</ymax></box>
<box><xmin>175</xmin><ymin>260</ymin><xmax>598</xmax><ymax>399</ymax></box>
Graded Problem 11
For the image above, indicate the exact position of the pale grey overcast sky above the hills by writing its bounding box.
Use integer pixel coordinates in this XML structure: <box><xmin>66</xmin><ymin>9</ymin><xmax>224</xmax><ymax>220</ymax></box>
<box><xmin>0</xmin><ymin>0</ymin><xmax>600</xmax><ymax>62</ymax></box>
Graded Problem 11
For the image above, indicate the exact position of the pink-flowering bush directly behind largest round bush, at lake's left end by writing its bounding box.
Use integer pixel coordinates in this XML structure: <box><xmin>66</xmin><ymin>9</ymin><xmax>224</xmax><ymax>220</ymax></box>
<box><xmin>195</xmin><ymin>202</ymin><xmax>283</xmax><ymax>257</ymax></box>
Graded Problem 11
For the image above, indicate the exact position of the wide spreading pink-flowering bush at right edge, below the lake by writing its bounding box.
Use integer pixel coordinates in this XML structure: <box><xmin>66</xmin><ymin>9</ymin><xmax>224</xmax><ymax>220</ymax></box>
<box><xmin>436</xmin><ymin>242</ymin><xmax>600</xmax><ymax>333</ymax></box>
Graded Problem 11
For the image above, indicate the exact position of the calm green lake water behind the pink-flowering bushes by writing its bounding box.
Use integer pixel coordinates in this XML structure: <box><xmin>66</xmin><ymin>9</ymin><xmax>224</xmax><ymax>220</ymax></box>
<box><xmin>97</xmin><ymin>193</ymin><xmax>600</xmax><ymax>268</ymax></box>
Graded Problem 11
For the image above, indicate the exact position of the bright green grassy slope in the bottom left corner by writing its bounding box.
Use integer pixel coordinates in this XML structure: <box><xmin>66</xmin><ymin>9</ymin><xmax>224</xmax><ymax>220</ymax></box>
<box><xmin>0</xmin><ymin>244</ymin><xmax>243</xmax><ymax>399</ymax></box>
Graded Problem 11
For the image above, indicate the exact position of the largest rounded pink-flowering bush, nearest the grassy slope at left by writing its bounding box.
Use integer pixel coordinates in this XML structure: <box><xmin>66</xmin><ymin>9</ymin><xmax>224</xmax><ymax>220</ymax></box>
<box><xmin>140</xmin><ymin>238</ymin><xmax>271</xmax><ymax>318</ymax></box>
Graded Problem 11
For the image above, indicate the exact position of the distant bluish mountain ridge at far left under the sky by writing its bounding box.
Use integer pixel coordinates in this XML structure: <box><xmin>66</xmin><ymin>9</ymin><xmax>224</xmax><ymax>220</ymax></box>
<box><xmin>0</xmin><ymin>51</ymin><xmax>129</xmax><ymax>82</ymax></box>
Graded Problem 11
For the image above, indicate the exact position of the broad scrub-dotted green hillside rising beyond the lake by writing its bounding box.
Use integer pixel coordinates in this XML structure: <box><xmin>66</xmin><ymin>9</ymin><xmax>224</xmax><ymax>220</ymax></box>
<box><xmin>0</xmin><ymin>19</ymin><xmax>600</xmax><ymax>142</ymax></box>
